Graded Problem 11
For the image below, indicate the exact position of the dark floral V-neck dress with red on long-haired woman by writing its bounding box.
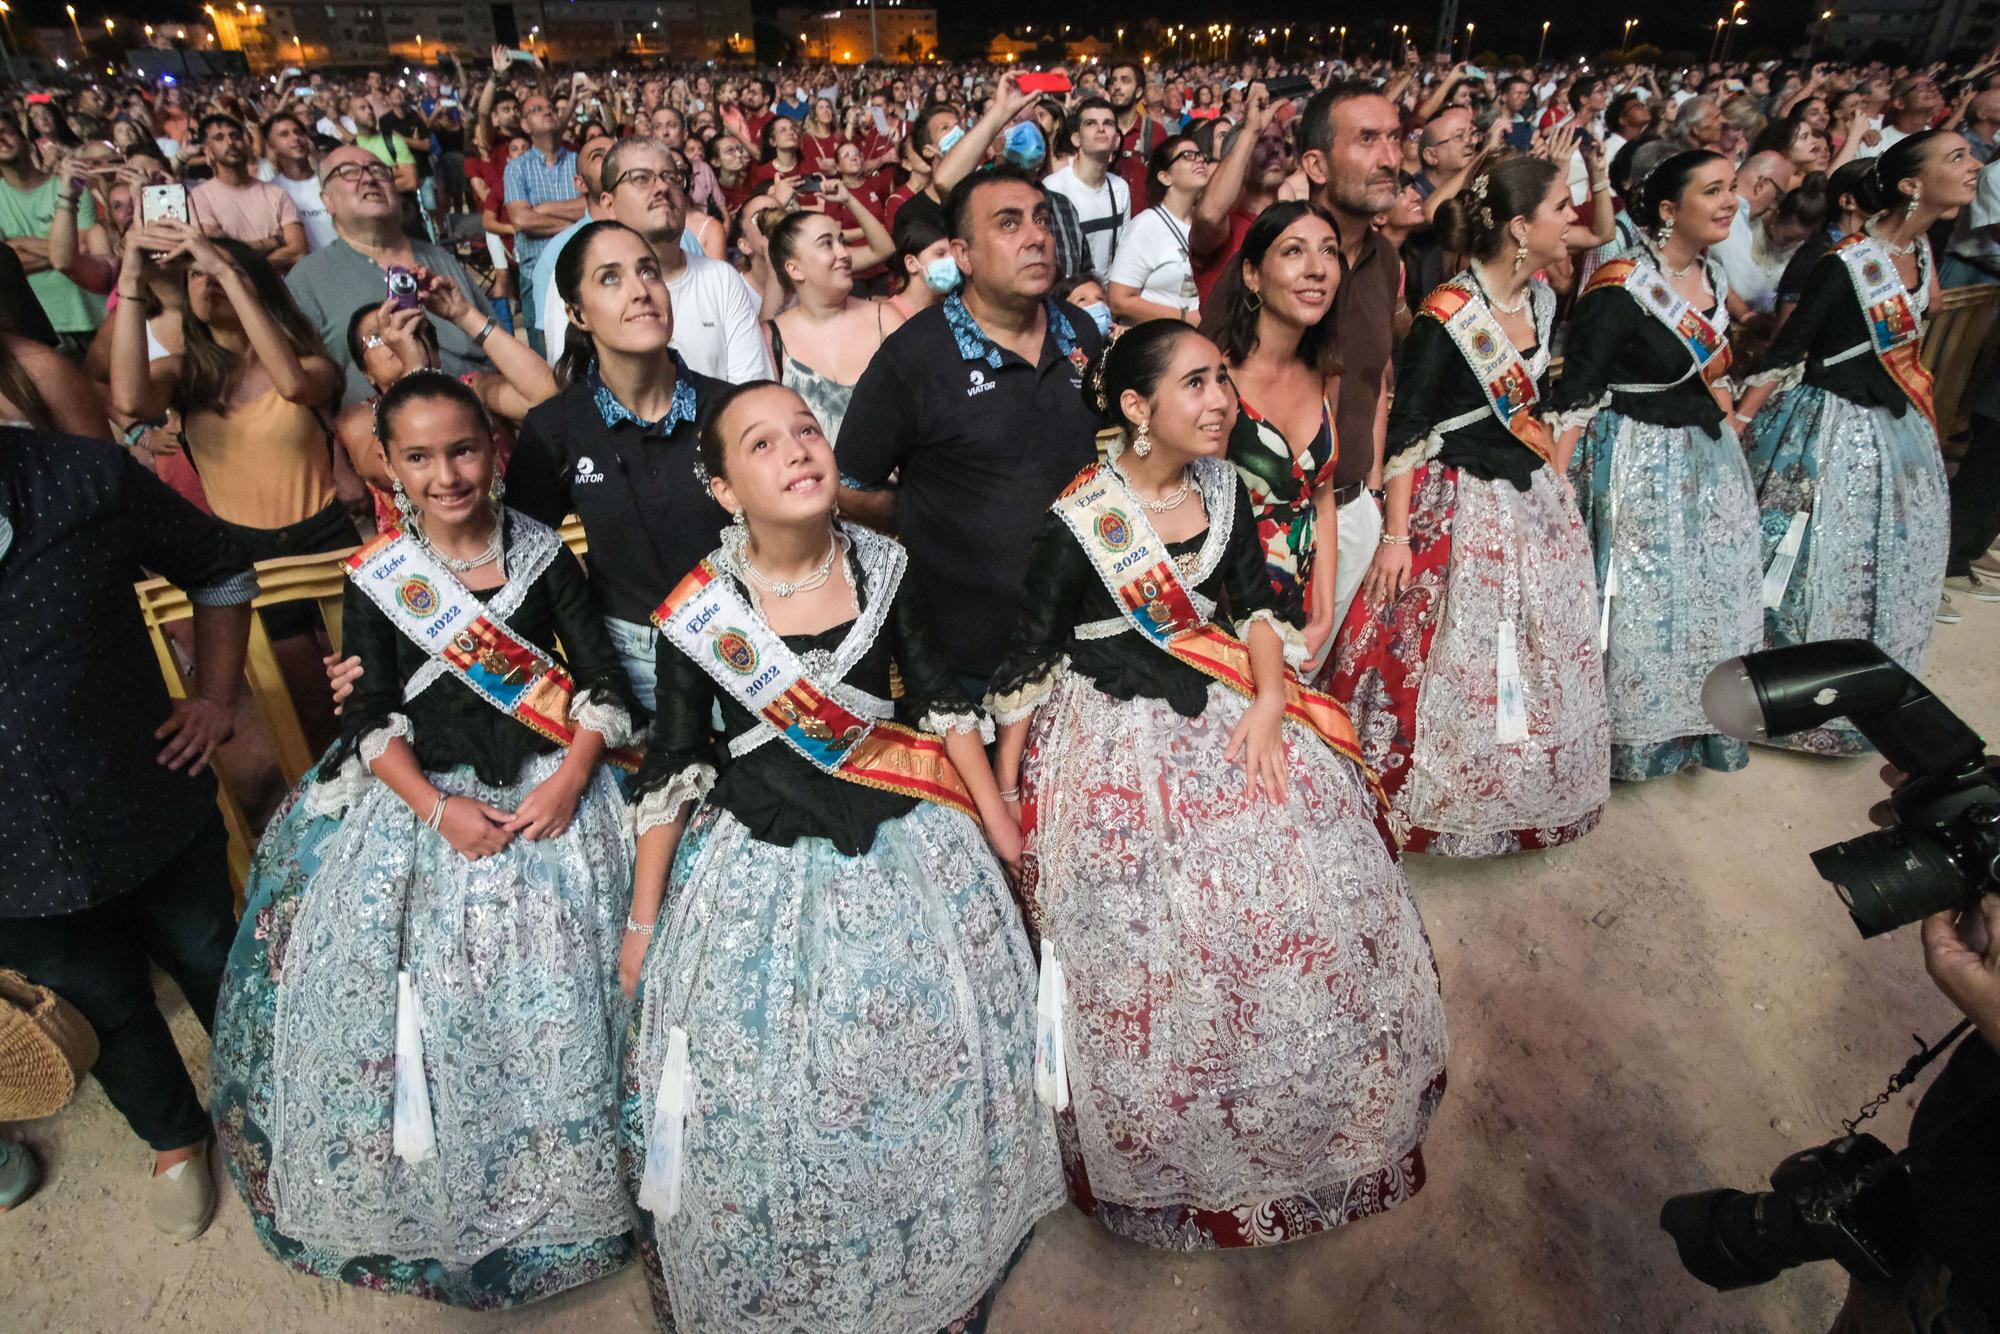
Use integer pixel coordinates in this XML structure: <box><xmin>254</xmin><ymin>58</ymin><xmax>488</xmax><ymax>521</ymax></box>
<box><xmin>1230</xmin><ymin>400</ymin><xmax>1340</xmax><ymax>630</ymax></box>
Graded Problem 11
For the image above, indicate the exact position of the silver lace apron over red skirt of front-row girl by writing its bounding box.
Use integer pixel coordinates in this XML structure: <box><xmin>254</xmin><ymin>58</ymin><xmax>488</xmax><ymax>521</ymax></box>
<box><xmin>1022</xmin><ymin>676</ymin><xmax>1446</xmax><ymax>1210</ymax></box>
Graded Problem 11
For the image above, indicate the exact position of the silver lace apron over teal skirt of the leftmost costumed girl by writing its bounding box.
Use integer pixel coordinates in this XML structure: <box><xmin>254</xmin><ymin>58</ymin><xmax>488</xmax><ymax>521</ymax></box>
<box><xmin>270</xmin><ymin>752</ymin><xmax>632</xmax><ymax>1266</ymax></box>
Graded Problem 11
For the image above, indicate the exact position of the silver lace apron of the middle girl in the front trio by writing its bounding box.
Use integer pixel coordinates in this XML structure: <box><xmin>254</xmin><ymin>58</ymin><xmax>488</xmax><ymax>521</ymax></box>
<box><xmin>630</xmin><ymin>804</ymin><xmax>1064</xmax><ymax>1334</ymax></box>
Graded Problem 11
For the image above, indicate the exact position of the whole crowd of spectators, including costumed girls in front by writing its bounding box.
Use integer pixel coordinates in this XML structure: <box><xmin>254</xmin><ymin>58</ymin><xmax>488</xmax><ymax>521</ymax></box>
<box><xmin>0</xmin><ymin>39</ymin><xmax>2000</xmax><ymax>1334</ymax></box>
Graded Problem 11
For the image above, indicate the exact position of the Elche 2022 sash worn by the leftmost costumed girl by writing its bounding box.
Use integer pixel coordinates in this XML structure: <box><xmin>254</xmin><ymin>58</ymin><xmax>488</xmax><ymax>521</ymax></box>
<box><xmin>346</xmin><ymin>530</ymin><xmax>640</xmax><ymax>770</ymax></box>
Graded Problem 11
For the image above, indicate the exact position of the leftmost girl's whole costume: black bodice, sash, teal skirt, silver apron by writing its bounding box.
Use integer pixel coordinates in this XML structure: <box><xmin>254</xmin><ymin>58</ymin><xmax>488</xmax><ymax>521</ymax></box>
<box><xmin>212</xmin><ymin>512</ymin><xmax>636</xmax><ymax>1308</ymax></box>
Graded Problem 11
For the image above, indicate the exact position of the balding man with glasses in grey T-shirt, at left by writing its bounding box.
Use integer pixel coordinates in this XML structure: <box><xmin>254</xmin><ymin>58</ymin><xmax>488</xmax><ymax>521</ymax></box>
<box><xmin>284</xmin><ymin>144</ymin><xmax>494</xmax><ymax>402</ymax></box>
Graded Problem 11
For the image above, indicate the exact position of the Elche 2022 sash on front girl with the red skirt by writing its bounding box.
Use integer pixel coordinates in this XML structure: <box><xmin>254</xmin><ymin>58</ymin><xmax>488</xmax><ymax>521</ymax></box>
<box><xmin>1052</xmin><ymin>464</ymin><xmax>1374</xmax><ymax>772</ymax></box>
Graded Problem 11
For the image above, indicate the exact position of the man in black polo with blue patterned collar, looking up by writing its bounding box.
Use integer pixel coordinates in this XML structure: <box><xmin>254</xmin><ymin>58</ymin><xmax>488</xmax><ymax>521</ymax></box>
<box><xmin>836</xmin><ymin>168</ymin><xmax>1102</xmax><ymax>698</ymax></box>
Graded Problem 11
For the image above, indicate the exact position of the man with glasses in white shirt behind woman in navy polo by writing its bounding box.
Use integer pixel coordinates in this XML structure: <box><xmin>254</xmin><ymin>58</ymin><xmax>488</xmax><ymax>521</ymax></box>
<box><xmin>542</xmin><ymin>138</ymin><xmax>776</xmax><ymax>384</ymax></box>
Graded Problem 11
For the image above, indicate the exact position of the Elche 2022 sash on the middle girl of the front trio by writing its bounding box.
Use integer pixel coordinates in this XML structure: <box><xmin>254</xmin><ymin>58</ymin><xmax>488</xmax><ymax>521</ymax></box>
<box><xmin>652</xmin><ymin>536</ymin><xmax>978</xmax><ymax>818</ymax></box>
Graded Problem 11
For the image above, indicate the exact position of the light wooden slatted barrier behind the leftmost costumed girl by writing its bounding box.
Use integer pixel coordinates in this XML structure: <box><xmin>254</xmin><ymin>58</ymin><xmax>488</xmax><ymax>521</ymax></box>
<box><xmin>134</xmin><ymin>518</ymin><xmax>586</xmax><ymax>908</ymax></box>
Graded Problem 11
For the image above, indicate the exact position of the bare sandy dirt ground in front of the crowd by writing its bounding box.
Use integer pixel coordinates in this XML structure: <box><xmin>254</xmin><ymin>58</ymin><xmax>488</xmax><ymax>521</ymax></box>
<box><xmin>0</xmin><ymin>600</ymin><xmax>2000</xmax><ymax>1334</ymax></box>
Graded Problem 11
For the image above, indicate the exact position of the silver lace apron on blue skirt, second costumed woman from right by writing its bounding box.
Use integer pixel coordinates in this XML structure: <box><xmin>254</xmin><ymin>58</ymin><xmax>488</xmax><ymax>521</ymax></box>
<box><xmin>1576</xmin><ymin>412</ymin><xmax>1764</xmax><ymax>746</ymax></box>
